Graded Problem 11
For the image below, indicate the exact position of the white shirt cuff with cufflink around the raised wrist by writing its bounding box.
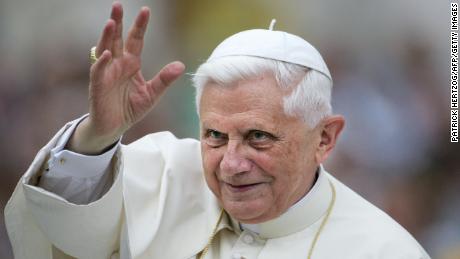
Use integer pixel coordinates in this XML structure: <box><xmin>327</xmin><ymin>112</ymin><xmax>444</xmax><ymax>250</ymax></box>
<box><xmin>38</xmin><ymin>115</ymin><xmax>121</xmax><ymax>204</ymax></box>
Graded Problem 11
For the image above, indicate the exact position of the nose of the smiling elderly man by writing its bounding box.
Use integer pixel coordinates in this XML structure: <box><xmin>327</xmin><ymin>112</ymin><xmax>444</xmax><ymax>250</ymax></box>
<box><xmin>220</xmin><ymin>141</ymin><xmax>252</xmax><ymax>175</ymax></box>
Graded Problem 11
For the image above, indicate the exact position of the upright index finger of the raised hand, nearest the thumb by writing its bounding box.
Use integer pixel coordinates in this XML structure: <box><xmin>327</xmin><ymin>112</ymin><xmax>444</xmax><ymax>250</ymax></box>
<box><xmin>125</xmin><ymin>7</ymin><xmax>150</xmax><ymax>56</ymax></box>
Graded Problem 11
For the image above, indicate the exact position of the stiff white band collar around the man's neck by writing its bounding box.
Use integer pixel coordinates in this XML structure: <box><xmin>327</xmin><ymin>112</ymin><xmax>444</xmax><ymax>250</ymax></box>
<box><xmin>232</xmin><ymin>165</ymin><xmax>332</xmax><ymax>238</ymax></box>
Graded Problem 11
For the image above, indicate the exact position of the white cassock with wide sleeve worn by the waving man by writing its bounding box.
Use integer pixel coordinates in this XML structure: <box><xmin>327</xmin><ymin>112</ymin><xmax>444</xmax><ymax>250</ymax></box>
<box><xmin>5</xmin><ymin>118</ymin><xmax>429</xmax><ymax>259</ymax></box>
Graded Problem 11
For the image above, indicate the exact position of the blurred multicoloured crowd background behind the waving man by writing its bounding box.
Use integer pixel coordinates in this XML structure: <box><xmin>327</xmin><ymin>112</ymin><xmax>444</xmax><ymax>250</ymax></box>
<box><xmin>0</xmin><ymin>0</ymin><xmax>460</xmax><ymax>259</ymax></box>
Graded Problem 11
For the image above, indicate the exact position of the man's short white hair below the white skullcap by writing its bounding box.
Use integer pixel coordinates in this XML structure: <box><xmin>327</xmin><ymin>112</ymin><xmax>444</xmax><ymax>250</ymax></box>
<box><xmin>192</xmin><ymin>56</ymin><xmax>332</xmax><ymax>128</ymax></box>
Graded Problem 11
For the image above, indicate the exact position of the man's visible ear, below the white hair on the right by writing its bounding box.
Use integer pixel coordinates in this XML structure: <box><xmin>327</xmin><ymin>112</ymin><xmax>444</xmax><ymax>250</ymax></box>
<box><xmin>315</xmin><ymin>115</ymin><xmax>345</xmax><ymax>164</ymax></box>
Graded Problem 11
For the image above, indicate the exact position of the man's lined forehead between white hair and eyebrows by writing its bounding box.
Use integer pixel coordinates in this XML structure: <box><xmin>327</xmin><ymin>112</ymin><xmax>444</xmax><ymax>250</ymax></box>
<box><xmin>199</xmin><ymin>74</ymin><xmax>292</xmax><ymax>128</ymax></box>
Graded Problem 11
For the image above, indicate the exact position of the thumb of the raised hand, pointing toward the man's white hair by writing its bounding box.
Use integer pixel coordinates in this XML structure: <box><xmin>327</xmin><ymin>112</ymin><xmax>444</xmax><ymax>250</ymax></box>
<box><xmin>147</xmin><ymin>61</ymin><xmax>185</xmax><ymax>96</ymax></box>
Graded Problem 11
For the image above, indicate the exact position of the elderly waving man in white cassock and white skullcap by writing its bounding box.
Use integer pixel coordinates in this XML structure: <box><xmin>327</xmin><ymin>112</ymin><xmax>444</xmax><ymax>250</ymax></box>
<box><xmin>6</xmin><ymin>3</ymin><xmax>429</xmax><ymax>259</ymax></box>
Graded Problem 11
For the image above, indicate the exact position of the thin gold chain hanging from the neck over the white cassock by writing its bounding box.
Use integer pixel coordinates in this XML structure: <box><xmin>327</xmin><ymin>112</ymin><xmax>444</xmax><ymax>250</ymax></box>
<box><xmin>197</xmin><ymin>180</ymin><xmax>336</xmax><ymax>259</ymax></box>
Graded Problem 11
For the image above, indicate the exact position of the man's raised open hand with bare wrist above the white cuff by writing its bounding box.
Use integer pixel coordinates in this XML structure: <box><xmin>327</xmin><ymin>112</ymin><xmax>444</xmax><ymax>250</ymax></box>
<box><xmin>67</xmin><ymin>2</ymin><xmax>184</xmax><ymax>154</ymax></box>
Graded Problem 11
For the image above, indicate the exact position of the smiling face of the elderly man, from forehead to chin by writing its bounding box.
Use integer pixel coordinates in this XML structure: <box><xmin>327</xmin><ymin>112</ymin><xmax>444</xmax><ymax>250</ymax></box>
<box><xmin>199</xmin><ymin>74</ymin><xmax>320</xmax><ymax>223</ymax></box>
